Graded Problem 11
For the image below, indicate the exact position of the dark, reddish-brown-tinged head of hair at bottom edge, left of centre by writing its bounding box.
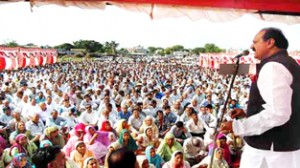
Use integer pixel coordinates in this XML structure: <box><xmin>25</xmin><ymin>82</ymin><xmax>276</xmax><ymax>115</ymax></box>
<box><xmin>108</xmin><ymin>149</ymin><xmax>136</xmax><ymax>168</ymax></box>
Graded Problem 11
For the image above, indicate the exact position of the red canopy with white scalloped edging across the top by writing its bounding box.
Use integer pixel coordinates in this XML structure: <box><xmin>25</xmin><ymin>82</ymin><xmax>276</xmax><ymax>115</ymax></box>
<box><xmin>30</xmin><ymin>0</ymin><xmax>300</xmax><ymax>24</ymax></box>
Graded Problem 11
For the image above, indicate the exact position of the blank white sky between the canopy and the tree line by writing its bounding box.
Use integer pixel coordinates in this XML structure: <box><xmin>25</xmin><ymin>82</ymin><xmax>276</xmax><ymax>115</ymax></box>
<box><xmin>0</xmin><ymin>2</ymin><xmax>300</xmax><ymax>50</ymax></box>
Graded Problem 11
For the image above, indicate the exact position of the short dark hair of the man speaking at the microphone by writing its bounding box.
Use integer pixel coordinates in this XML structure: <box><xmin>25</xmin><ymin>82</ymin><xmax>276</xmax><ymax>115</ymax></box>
<box><xmin>262</xmin><ymin>27</ymin><xmax>289</xmax><ymax>49</ymax></box>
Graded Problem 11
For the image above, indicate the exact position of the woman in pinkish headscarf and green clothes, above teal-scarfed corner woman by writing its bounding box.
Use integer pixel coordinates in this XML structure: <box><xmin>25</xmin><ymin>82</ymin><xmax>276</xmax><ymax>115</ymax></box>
<box><xmin>10</xmin><ymin>134</ymin><xmax>38</xmax><ymax>163</ymax></box>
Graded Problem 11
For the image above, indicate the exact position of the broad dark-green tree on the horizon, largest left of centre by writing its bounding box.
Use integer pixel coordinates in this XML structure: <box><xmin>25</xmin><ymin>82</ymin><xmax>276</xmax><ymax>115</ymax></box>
<box><xmin>73</xmin><ymin>40</ymin><xmax>103</xmax><ymax>52</ymax></box>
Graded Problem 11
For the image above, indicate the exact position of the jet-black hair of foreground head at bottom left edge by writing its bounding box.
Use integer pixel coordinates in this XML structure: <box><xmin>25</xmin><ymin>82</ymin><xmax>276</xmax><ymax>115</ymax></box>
<box><xmin>32</xmin><ymin>146</ymin><xmax>61</xmax><ymax>168</ymax></box>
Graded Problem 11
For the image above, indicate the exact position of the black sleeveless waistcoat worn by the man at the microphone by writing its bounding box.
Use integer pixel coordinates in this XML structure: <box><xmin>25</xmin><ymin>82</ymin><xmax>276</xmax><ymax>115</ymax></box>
<box><xmin>245</xmin><ymin>50</ymin><xmax>300</xmax><ymax>151</ymax></box>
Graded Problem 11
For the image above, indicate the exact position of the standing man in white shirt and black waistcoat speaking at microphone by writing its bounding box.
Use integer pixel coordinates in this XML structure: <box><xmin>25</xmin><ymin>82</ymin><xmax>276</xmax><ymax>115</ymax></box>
<box><xmin>220</xmin><ymin>28</ymin><xmax>300</xmax><ymax>168</ymax></box>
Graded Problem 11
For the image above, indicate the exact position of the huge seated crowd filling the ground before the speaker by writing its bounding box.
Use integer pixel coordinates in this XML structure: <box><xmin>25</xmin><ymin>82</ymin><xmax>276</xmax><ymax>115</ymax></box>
<box><xmin>0</xmin><ymin>61</ymin><xmax>251</xmax><ymax>168</ymax></box>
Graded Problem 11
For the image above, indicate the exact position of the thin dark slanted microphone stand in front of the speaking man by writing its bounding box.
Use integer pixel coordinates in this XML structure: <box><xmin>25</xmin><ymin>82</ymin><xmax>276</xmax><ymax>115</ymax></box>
<box><xmin>209</xmin><ymin>57</ymin><xmax>240</xmax><ymax>168</ymax></box>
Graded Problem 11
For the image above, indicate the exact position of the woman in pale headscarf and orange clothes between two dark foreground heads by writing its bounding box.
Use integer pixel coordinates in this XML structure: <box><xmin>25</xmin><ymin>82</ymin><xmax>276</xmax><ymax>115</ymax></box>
<box><xmin>70</xmin><ymin>141</ymin><xmax>95</xmax><ymax>168</ymax></box>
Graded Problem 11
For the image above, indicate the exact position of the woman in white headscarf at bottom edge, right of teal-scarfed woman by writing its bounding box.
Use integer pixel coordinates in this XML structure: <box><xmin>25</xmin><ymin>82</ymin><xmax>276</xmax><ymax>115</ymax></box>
<box><xmin>163</xmin><ymin>150</ymin><xmax>190</xmax><ymax>168</ymax></box>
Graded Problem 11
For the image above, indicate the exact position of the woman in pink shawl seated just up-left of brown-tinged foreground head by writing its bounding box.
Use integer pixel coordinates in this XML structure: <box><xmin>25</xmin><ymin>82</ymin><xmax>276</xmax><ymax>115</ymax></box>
<box><xmin>84</xmin><ymin>126</ymin><xmax>110</xmax><ymax>163</ymax></box>
